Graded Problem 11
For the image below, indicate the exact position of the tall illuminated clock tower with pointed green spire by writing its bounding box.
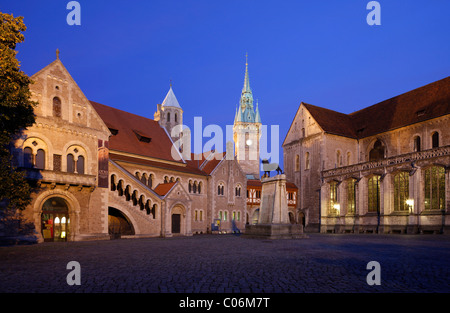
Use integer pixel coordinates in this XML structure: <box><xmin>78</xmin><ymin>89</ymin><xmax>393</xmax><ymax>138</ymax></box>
<box><xmin>233</xmin><ymin>56</ymin><xmax>261</xmax><ymax>179</ymax></box>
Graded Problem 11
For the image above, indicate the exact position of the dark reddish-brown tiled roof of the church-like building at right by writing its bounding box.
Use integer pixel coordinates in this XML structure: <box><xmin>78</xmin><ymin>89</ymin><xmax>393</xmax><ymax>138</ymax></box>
<box><xmin>302</xmin><ymin>77</ymin><xmax>450</xmax><ymax>138</ymax></box>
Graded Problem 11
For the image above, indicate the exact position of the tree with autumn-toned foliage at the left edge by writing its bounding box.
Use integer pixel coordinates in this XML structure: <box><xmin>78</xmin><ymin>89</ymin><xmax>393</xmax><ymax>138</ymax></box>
<box><xmin>0</xmin><ymin>12</ymin><xmax>36</xmax><ymax>241</ymax></box>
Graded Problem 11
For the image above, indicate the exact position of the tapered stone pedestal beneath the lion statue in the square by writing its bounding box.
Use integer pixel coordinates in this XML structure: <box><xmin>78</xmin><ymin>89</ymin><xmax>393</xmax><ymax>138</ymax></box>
<box><xmin>244</xmin><ymin>174</ymin><xmax>306</xmax><ymax>239</ymax></box>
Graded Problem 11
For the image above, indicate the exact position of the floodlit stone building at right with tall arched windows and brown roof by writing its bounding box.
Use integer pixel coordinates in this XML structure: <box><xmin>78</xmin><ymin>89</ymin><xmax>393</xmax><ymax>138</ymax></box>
<box><xmin>283</xmin><ymin>77</ymin><xmax>450</xmax><ymax>233</ymax></box>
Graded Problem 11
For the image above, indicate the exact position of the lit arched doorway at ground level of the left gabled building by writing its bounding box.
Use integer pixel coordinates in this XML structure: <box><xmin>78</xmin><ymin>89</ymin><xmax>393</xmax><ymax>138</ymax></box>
<box><xmin>41</xmin><ymin>197</ymin><xmax>70</xmax><ymax>242</ymax></box>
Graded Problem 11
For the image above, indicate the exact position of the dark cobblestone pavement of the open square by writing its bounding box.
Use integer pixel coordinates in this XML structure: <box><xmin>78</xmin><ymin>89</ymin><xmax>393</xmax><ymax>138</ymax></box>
<box><xmin>0</xmin><ymin>234</ymin><xmax>450</xmax><ymax>293</ymax></box>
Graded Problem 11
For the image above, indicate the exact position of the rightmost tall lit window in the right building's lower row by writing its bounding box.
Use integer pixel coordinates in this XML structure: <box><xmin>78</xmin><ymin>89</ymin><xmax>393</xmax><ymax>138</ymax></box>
<box><xmin>424</xmin><ymin>166</ymin><xmax>445</xmax><ymax>210</ymax></box>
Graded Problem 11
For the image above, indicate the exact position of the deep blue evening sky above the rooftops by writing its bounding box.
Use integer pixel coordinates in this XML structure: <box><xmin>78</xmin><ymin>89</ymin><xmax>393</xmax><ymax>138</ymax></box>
<box><xmin>0</xmin><ymin>0</ymin><xmax>450</xmax><ymax>166</ymax></box>
